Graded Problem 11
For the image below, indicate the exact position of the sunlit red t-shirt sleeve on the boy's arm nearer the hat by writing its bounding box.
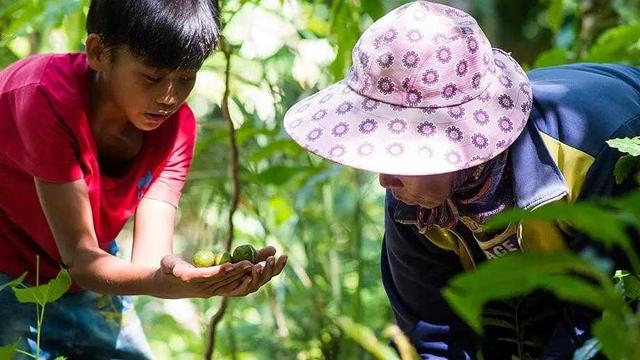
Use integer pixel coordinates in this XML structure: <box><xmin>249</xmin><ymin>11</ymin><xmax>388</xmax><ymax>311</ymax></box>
<box><xmin>144</xmin><ymin>108</ymin><xmax>196</xmax><ymax>208</ymax></box>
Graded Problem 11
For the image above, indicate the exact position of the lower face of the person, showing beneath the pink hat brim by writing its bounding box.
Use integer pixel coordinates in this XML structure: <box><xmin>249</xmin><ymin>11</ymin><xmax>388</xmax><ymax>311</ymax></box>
<box><xmin>379</xmin><ymin>173</ymin><xmax>454</xmax><ymax>209</ymax></box>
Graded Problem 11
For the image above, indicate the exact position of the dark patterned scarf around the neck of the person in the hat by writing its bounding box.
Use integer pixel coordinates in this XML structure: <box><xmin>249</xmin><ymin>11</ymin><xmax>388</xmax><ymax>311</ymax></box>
<box><xmin>418</xmin><ymin>151</ymin><xmax>514</xmax><ymax>233</ymax></box>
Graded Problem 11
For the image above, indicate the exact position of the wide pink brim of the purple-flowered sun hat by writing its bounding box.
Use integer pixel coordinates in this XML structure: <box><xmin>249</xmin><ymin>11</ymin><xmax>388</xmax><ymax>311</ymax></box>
<box><xmin>284</xmin><ymin>49</ymin><xmax>532</xmax><ymax>175</ymax></box>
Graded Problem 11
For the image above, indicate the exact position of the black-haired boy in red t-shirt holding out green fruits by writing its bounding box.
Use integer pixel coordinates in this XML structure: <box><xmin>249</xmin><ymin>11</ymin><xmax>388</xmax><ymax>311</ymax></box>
<box><xmin>0</xmin><ymin>0</ymin><xmax>286</xmax><ymax>358</ymax></box>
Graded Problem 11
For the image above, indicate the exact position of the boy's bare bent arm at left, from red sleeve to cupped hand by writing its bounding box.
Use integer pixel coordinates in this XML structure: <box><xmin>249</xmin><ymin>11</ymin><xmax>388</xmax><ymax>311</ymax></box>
<box><xmin>34</xmin><ymin>178</ymin><xmax>251</xmax><ymax>298</ymax></box>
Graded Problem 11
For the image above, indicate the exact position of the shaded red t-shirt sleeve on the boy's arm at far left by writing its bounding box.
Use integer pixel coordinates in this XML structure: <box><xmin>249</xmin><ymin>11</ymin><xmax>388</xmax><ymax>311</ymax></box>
<box><xmin>4</xmin><ymin>85</ymin><xmax>84</xmax><ymax>183</ymax></box>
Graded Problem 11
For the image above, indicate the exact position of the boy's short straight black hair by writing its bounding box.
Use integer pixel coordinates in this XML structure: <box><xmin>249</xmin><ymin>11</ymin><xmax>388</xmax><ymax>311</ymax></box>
<box><xmin>87</xmin><ymin>0</ymin><xmax>220</xmax><ymax>70</ymax></box>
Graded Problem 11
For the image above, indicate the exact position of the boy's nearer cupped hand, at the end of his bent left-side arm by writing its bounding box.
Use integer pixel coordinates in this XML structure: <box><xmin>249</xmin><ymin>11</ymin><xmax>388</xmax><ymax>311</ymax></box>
<box><xmin>158</xmin><ymin>255</ymin><xmax>253</xmax><ymax>298</ymax></box>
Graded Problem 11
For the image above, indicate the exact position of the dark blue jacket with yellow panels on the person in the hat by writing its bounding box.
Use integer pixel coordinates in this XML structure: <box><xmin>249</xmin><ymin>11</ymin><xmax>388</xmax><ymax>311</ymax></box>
<box><xmin>382</xmin><ymin>64</ymin><xmax>640</xmax><ymax>359</ymax></box>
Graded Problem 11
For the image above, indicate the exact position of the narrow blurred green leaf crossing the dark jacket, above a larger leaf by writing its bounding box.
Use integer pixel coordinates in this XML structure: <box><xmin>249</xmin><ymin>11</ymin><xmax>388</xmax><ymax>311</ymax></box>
<box><xmin>487</xmin><ymin>201</ymin><xmax>630</xmax><ymax>249</ymax></box>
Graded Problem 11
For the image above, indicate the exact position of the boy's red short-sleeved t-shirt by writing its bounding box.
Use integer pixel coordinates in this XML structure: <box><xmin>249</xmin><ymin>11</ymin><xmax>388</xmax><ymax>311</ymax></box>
<box><xmin>0</xmin><ymin>53</ymin><xmax>196</xmax><ymax>282</ymax></box>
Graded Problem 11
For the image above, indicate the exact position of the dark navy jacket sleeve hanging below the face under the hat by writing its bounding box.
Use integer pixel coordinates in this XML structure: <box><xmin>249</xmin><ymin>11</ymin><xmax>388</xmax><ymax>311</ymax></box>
<box><xmin>381</xmin><ymin>192</ymin><xmax>475</xmax><ymax>359</ymax></box>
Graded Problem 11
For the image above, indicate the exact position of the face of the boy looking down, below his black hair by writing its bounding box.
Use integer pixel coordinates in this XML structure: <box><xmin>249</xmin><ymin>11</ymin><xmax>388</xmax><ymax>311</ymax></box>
<box><xmin>90</xmin><ymin>34</ymin><xmax>198</xmax><ymax>131</ymax></box>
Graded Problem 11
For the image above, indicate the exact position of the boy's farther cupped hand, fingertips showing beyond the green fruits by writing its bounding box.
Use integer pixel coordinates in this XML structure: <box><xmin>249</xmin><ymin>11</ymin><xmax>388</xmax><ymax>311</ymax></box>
<box><xmin>220</xmin><ymin>246</ymin><xmax>287</xmax><ymax>296</ymax></box>
